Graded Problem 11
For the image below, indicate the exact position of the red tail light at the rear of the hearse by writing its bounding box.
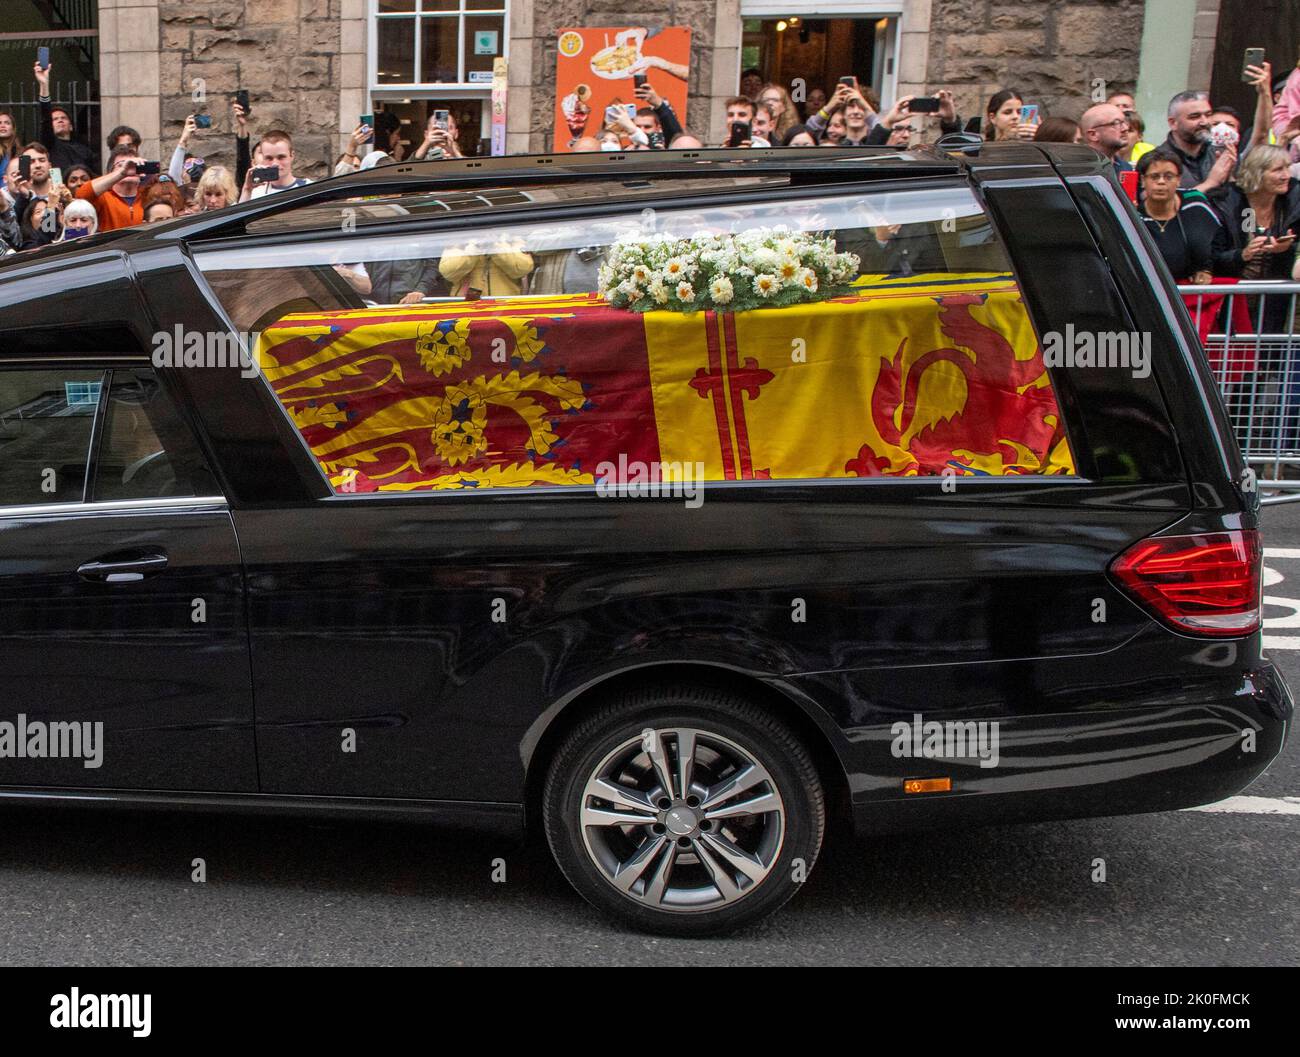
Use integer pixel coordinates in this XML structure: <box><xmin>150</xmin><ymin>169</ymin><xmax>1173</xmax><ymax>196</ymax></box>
<box><xmin>1110</xmin><ymin>529</ymin><xmax>1262</xmax><ymax>638</ymax></box>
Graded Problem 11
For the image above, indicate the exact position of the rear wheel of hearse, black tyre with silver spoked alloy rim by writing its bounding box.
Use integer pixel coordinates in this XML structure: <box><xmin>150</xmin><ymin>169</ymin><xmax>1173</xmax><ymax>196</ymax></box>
<box><xmin>542</xmin><ymin>685</ymin><xmax>826</xmax><ymax>936</ymax></box>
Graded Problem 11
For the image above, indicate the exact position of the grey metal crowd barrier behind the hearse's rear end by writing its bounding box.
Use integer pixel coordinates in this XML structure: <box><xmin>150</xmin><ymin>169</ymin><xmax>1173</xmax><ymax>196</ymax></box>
<box><xmin>1178</xmin><ymin>281</ymin><xmax>1300</xmax><ymax>503</ymax></box>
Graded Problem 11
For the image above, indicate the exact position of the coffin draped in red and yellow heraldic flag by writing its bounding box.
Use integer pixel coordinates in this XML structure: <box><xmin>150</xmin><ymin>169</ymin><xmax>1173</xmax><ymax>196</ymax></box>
<box><xmin>257</xmin><ymin>274</ymin><xmax>1074</xmax><ymax>491</ymax></box>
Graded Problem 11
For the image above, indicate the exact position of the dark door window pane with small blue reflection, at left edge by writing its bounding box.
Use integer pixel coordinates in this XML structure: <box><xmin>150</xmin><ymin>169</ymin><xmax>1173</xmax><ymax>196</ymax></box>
<box><xmin>0</xmin><ymin>368</ymin><xmax>105</xmax><ymax>506</ymax></box>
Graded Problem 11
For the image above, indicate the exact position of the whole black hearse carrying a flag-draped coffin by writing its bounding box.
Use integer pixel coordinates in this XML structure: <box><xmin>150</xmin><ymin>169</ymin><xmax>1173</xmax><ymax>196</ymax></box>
<box><xmin>0</xmin><ymin>144</ymin><xmax>1292</xmax><ymax>933</ymax></box>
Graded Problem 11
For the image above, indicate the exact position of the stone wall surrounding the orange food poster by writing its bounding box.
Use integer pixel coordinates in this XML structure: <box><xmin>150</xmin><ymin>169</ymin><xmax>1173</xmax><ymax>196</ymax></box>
<box><xmin>510</xmin><ymin>0</ymin><xmax>740</xmax><ymax>152</ymax></box>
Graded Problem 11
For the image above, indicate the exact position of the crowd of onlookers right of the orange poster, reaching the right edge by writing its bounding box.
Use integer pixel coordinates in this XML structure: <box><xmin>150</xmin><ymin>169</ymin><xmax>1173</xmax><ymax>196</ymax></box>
<box><xmin>573</xmin><ymin>52</ymin><xmax>1300</xmax><ymax>291</ymax></box>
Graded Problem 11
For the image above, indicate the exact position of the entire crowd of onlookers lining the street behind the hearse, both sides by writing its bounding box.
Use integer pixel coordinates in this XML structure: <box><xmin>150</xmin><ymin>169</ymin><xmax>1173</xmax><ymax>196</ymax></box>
<box><xmin>0</xmin><ymin>47</ymin><xmax>1300</xmax><ymax>291</ymax></box>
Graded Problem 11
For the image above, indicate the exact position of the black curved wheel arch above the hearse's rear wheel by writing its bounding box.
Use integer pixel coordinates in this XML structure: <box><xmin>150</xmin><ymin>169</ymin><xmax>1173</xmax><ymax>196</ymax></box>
<box><xmin>520</xmin><ymin>662</ymin><xmax>853</xmax><ymax>835</ymax></box>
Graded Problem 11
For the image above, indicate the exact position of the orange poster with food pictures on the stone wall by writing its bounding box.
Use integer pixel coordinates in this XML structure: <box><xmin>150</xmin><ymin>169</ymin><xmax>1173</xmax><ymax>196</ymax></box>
<box><xmin>555</xmin><ymin>26</ymin><xmax>690</xmax><ymax>153</ymax></box>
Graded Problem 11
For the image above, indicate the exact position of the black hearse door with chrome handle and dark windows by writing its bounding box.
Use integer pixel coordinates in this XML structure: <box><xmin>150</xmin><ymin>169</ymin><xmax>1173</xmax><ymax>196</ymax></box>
<box><xmin>0</xmin><ymin>358</ymin><xmax>257</xmax><ymax>792</ymax></box>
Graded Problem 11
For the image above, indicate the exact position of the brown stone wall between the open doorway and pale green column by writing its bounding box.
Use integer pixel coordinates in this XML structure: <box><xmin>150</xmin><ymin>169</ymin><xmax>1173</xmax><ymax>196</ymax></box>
<box><xmin>927</xmin><ymin>0</ymin><xmax>1144</xmax><ymax>128</ymax></box>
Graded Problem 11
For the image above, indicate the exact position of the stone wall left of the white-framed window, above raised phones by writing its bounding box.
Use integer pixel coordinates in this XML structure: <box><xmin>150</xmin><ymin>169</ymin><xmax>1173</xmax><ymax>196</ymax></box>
<box><xmin>157</xmin><ymin>0</ymin><xmax>348</xmax><ymax>178</ymax></box>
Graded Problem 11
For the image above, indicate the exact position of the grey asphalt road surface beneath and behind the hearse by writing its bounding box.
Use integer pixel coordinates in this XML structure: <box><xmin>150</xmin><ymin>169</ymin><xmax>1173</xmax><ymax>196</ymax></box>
<box><xmin>0</xmin><ymin>504</ymin><xmax>1300</xmax><ymax>966</ymax></box>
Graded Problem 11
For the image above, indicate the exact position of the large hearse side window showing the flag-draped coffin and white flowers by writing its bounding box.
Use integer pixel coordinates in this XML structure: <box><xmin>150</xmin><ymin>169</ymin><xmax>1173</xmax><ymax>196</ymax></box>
<box><xmin>196</xmin><ymin>186</ymin><xmax>1074</xmax><ymax>493</ymax></box>
